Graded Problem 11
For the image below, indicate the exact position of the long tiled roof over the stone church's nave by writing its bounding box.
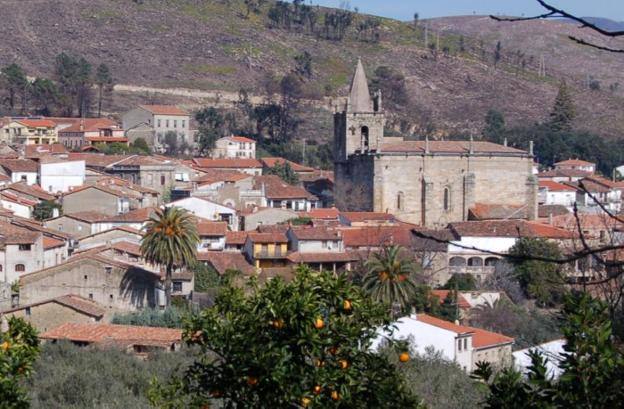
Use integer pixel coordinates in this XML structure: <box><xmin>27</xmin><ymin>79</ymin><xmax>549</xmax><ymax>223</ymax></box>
<box><xmin>381</xmin><ymin>141</ymin><xmax>527</xmax><ymax>155</ymax></box>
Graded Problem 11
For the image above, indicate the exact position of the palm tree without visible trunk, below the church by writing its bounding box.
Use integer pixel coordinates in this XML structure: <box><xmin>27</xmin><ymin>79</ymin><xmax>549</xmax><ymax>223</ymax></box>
<box><xmin>363</xmin><ymin>246</ymin><xmax>418</xmax><ymax>310</ymax></box>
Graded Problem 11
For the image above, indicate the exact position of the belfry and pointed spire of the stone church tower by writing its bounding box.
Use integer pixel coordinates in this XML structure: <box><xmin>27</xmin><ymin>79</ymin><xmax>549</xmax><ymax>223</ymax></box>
<box><xmin>334</xmin><ymin>59</ymin><xmax>385</xmax><ymax>163</ymax></box>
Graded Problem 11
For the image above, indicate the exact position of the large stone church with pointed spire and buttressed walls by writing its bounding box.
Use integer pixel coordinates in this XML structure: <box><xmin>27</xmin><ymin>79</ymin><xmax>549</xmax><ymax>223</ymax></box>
<box><xmin>334</xmin><ymin>61</ymin><xmax>538</xmax><ymax>227</ymax></box>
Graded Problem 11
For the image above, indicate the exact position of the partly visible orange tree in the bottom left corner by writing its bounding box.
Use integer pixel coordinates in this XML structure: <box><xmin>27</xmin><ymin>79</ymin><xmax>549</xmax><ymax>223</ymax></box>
<box><xmin>0</xmin><ymin>317</ymin><xmax>39</xmax><ymax>409</ymax></box>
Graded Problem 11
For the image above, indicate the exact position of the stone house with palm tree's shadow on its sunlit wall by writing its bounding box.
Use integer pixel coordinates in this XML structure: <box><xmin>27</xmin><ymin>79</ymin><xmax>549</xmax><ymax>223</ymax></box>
<box><xmin>19</xmin><ymin>253</ymin><xmax>163</xmax><ymax>311</ymax></box>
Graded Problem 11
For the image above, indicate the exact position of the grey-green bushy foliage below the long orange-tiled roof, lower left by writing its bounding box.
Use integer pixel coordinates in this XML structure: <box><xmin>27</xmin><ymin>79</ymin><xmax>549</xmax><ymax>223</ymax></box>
<box><xmin>28</xmin><ymin>342</ymin><xmax>191</xmax><ymax>409</ymax></box>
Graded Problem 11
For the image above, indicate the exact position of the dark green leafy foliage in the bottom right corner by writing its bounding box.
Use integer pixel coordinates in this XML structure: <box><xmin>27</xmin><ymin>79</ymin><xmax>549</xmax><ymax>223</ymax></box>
<box><xmin>475</xmin><ymin>294</ymin><xmax>624</xmax><ymax>409</ymax></box>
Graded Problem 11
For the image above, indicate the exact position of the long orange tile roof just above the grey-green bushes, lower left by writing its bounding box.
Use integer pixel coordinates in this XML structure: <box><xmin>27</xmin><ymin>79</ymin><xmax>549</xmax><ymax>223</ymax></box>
<box><xmin>39</xmin><ymin>323</ymin><xmax>182</xmax><ymax>345</ymax></box>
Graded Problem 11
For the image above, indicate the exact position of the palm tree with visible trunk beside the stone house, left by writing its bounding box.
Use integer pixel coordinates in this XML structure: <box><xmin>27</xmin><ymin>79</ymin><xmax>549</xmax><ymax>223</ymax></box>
<box><xmin>141</xmin><ymin>207</ymin><xmax>199</xmax><ymax>307</ymax></box>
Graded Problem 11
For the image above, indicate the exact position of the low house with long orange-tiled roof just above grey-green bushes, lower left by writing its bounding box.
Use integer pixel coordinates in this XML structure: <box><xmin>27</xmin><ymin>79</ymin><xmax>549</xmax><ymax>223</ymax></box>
<box><xmin>39</xmin><ymin>323</ymin><xmax>182</xmax><ymax>356</ymax></box>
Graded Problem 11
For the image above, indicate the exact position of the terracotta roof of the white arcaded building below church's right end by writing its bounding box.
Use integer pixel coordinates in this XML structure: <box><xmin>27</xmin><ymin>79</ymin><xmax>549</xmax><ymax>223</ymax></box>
<box><xmin>449</xmin><ymin>220</ymin><xmax>576</xmax><ymax>239</ymax></box>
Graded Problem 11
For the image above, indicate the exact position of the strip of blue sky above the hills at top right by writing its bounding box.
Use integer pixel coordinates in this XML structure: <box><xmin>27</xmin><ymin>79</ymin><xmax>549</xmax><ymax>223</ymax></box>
<box><xmin>306</xmin><ymin>0</ymin><xmax>624</xmax><ymax>21</ymax></box>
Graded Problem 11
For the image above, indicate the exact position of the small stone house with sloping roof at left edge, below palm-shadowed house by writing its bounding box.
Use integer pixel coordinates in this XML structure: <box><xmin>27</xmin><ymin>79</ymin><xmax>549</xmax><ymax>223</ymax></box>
<box><xmin>0</xmin><ymin>294</ymin><xmax>107</xmax><ymax>333</ymax></box>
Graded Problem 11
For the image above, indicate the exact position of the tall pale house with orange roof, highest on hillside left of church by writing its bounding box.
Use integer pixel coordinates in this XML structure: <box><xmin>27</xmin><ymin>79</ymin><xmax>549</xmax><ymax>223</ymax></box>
<box><xmin>122</xmin><ymin>105</ymin><xmax>194</xmax><ymax>150</ymax></box>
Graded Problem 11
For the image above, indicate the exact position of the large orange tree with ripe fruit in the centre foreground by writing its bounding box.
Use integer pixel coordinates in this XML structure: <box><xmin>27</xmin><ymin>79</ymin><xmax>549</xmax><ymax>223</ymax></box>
<box><xmin>151</xmin><ymin>267</ymin><xmax>420</xmax><ymax>408</ymax></box>
